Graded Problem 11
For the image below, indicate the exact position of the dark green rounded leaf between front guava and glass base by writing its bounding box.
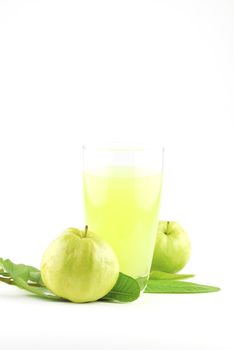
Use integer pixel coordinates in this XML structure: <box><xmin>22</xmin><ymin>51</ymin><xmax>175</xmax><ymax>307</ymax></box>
<box><xmin>101</xmin><ymin>272</ymin><xmax>140</xmax><ymax>302</ymax></box>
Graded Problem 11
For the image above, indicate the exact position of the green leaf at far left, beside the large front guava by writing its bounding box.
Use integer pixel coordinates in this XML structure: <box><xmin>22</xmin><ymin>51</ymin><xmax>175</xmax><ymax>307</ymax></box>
<box><xmin>0</xmin><ymin>259</ymin><xmax>63</xmax><ymax>300</ymax></box>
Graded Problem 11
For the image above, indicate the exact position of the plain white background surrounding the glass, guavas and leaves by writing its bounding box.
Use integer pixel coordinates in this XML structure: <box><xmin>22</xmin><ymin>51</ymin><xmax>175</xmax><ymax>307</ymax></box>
<box><xmin>0</xmin><ymin>0</ymin><xmax>234</xmax><ymax>350</ymax></box>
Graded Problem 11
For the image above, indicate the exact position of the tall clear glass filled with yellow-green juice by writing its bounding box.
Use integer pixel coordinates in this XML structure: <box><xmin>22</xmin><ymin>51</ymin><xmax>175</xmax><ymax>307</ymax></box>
<box><xmin>83</xmin><ymin>146</ymin><xmax>163</xmax><ymax>284</ymax></box>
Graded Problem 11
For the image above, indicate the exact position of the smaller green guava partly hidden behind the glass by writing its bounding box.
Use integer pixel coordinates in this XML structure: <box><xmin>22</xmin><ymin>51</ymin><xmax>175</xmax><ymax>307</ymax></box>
<box><xmin>151</xmin><ymin>221</ymin><xmax>191</xmax><ymax>273</ymax></box>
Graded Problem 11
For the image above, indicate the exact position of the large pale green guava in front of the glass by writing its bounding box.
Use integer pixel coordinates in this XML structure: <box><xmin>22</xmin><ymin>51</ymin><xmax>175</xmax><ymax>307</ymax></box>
<box><xmin>41</xmin><ymin>228</ymin><xmax>119</xmax><ymax>303</ymax></box>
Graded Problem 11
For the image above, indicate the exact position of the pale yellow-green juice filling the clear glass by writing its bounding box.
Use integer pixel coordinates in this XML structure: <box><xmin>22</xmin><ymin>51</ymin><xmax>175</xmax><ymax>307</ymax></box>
<box><xmin>84</xmin><ymin>167</ymin><xmax>162</xmax><ymax>278</ymax></box>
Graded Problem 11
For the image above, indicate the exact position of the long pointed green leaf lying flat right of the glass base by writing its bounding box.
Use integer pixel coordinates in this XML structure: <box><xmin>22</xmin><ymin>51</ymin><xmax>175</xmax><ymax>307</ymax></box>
<box><xmin>144</xmin><ymin>280</ymin><xmax>220</xmax><ymax>294</ymax></box>
